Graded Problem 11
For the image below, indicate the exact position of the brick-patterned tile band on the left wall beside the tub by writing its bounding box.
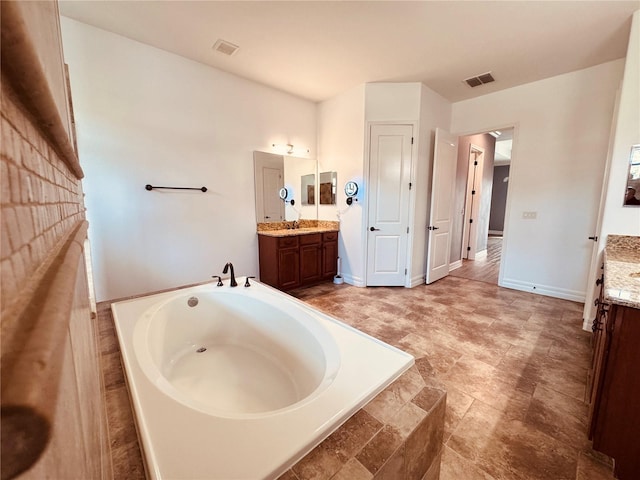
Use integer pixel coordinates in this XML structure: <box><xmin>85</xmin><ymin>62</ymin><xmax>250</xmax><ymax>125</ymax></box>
<box><xmin>0</xmin><ymin>79</ymin><xmax>85</xmax><ymax>315</ymax></box>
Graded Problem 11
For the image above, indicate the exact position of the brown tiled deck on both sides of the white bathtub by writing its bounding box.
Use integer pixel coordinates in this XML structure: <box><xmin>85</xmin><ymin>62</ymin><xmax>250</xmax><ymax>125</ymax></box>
<box><xmin>98</xmin><ymin>292</ymin><xmax>446</xmax><ymax>480</ymax></box>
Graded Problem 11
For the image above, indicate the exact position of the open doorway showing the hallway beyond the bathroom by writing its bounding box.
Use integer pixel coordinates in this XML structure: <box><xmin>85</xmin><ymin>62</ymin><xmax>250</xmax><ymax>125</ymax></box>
<box><xmin>450</xmin><ymin>127</ymin><xmax>514</xmax><ymax>285</ymax></box>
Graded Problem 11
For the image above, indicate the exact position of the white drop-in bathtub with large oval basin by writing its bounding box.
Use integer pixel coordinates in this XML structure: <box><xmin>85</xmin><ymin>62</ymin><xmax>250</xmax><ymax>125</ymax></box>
<box><xmin>111</xmin><ymin>279</ymin><xmax>413</xmax><ymax>480</ymax></box>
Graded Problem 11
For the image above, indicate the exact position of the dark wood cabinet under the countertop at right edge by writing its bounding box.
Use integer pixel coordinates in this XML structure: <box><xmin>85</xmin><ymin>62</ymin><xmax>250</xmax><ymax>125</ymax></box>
<box><xmin>588</xmin><ymin>278</ymin><xmax>640</xmax><ymax>480</ymax></box>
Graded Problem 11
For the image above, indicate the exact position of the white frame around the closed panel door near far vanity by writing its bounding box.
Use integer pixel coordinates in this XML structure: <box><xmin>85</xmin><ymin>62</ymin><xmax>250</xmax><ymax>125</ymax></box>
<box><xmin>362</xmin><ymin>120</ymin><xmax>420</xmax><ymax>288</ymax></box>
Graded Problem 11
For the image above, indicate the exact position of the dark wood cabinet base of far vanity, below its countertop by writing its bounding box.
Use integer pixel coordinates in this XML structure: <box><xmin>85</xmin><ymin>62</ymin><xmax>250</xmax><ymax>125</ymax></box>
<box><xmin>258</xmin><ymin>232</ymin><xmax>338</xmax><ymax>290</ymax></box>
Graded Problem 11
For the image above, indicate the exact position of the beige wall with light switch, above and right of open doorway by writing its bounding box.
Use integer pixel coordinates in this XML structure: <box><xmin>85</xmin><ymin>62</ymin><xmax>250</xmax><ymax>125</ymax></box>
<box><xmin>451</xmin><ymin>60</ymin><xmax>624</xmax><ymax>302</ymax></box>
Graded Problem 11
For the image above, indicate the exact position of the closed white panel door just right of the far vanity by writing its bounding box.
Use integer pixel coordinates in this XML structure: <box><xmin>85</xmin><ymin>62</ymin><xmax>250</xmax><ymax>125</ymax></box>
<box><xmin>366</xmin><ymin>125</ymin><xmax>413</xmax><ymax>286</ymax></box>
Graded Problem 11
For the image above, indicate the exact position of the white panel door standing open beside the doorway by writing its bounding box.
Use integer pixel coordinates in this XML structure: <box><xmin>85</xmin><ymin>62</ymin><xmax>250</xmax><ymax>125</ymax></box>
<box><xmin>426</xmin><ymin>129</ymin><xmax>458</xmax><ymax>283</ymax></box>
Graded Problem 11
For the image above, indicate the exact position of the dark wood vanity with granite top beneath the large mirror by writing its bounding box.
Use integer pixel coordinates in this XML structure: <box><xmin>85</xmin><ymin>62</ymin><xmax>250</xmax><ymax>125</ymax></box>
<box><xmin>258</xmin><ymin>220</ymin><xmax>340</xmax><ymax>290</ymax></box>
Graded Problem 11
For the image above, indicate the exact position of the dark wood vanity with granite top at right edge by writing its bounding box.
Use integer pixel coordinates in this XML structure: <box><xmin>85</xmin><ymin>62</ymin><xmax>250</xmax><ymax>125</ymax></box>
<box><xmin>587</xmin><ymin>235</ymin><xmax>640</xmax><ymax>480</ymax></box>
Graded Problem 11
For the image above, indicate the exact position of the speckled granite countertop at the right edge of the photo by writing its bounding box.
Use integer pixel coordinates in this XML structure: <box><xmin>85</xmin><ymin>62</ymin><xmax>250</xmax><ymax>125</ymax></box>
<box><xmin>604</xmin><ymin>235</ymin><xmax>640</xmax><ymax>308</ymax></box>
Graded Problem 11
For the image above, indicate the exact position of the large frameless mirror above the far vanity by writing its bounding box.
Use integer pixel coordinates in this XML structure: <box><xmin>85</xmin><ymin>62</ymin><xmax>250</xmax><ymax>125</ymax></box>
<box><xmin>253</xmin><ymin>151</ymin><xmax>318</xmax><ymax>223</ymax></box>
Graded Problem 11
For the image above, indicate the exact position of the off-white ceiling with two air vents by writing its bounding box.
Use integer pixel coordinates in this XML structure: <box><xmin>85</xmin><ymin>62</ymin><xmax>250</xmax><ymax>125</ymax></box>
<box><xmin>60</xmin><ymin>0</ymin><xmax>640</xmax><ymax>102</ymax></box>
